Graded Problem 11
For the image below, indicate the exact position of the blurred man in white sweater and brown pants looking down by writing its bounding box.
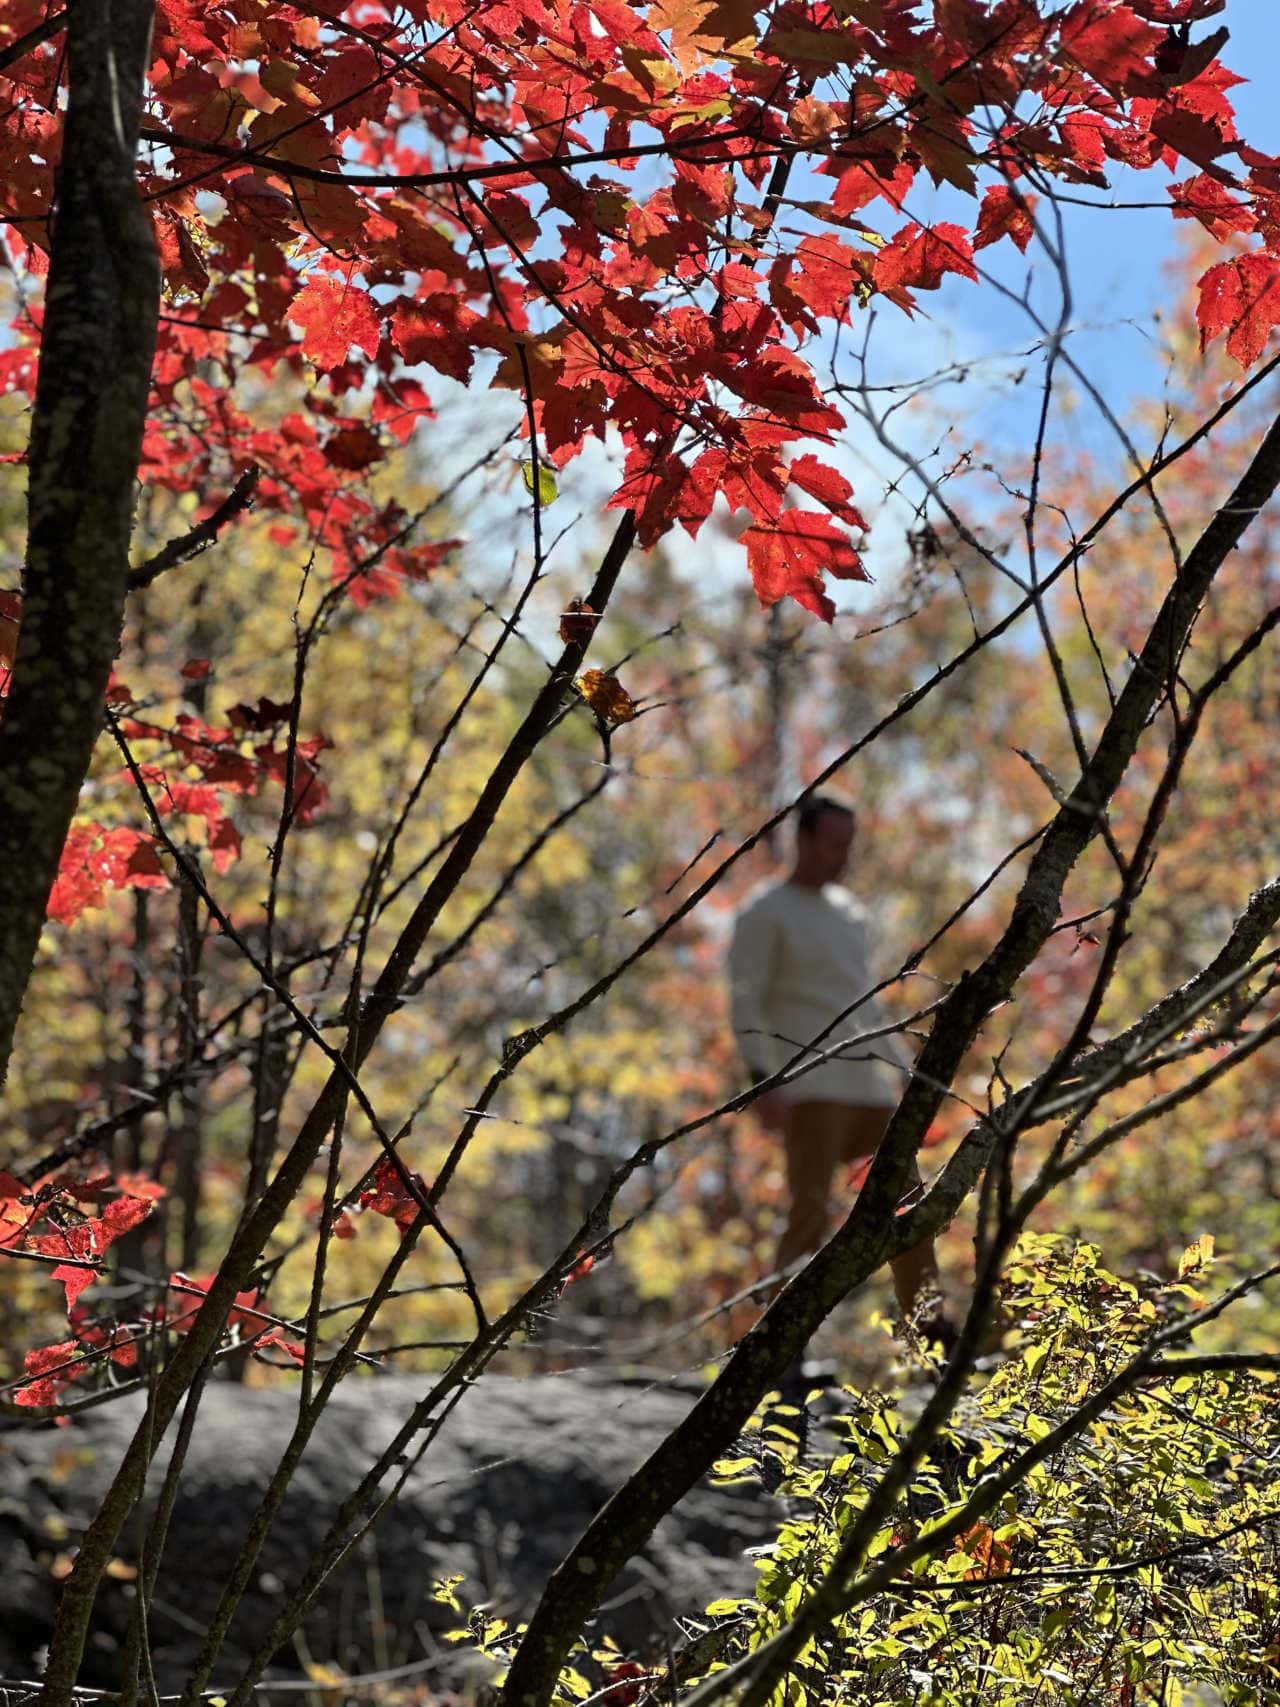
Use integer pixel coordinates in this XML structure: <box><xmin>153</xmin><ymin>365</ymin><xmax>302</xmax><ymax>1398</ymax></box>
<box><xmin>729</xmin><ymin>794</ymin><xmax>954</xmax><ymax>1384</ymax></box>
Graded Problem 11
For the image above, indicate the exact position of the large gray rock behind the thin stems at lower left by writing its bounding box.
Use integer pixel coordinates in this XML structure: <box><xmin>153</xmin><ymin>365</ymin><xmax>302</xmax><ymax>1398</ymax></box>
<box><xmin>0</xmin><ymin>1374</ymin><xmax>782</xmax><ymax>1690</ymax></box>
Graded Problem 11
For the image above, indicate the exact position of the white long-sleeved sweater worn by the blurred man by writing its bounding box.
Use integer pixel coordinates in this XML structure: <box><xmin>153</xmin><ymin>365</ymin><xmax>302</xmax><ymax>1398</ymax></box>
<box><xmin>729</xmin><ymin>883</ymin><xmax>906</xmax><ymax>1108</ymax></box>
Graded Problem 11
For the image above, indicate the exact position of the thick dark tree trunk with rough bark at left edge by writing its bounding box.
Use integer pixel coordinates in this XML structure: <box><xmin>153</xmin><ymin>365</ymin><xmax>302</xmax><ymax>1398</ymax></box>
<box><xmin>0</xmin><ymin>0</ymin><xmax>160</xmax><ymax>1077</ymax></box>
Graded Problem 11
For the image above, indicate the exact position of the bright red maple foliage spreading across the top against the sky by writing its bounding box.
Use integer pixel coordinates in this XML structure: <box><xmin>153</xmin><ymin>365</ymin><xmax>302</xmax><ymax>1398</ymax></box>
<box><xmin>0</xmin><ymin>0</ymin><xmax>1280</xmax><ymax>922</ymax></box>
